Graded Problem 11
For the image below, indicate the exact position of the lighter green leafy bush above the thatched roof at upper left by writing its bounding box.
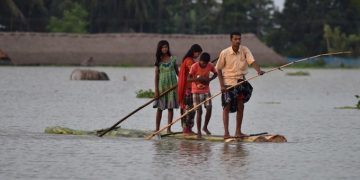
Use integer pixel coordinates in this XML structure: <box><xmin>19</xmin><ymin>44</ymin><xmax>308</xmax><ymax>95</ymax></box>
<box><xmin>47</xmin><ymin>3</ymin><xmax>88</xmax><ymax>33</ymax></box>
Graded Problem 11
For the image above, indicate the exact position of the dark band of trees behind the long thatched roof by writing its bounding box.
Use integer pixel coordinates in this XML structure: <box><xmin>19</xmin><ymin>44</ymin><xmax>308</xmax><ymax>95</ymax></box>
<box><xmin>0</xmin><ymin>0</ymin><xmax>360</xmax><ymax>57</ymax></box>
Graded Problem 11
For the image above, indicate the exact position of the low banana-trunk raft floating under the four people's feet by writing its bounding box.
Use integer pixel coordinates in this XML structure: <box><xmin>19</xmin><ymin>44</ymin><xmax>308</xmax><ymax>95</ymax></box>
<box><xmin>45</xmin><ymin>126</ymin><xmax>287</xmax><ymax>143</ymax></box>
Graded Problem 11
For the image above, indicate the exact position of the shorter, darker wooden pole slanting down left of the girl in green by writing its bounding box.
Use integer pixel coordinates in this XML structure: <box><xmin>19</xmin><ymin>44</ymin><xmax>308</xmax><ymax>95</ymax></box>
<box><xmin>97</xmin><ymin>57</ymin><xmax>219</xmax><ymax>137</ymax></box>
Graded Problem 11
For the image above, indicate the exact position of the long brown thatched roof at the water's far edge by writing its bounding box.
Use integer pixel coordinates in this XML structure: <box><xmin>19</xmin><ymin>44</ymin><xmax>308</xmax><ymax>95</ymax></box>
<box><xmin>0</xmin><ymin>32</ymin><xmax>285</xmax><ymax>66</ymax></box>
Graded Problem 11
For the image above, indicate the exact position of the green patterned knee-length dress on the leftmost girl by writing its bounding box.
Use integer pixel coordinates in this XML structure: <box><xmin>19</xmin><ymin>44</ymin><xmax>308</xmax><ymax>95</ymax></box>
<box><xmin>154</xmin><ymin>56</ymin><xmax>179</xmax><ymax>110</ymax></box>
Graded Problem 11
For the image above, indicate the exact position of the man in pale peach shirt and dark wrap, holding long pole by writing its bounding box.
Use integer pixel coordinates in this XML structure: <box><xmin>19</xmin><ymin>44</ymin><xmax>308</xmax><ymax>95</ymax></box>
<box><xmin>216</xmin><ymin>32</ymin><xmax>265</xmax><ymax>139</ymax></box>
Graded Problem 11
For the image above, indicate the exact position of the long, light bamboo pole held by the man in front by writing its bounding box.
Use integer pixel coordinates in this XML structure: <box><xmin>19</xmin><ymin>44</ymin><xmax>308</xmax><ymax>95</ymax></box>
<box><xmin>145</xmin><ymin>51</ymin><xmax>351</xmax><ymax>140</ymax></box>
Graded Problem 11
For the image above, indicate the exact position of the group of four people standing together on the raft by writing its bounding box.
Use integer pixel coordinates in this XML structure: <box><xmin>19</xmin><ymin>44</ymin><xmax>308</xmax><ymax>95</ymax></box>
<box><xmin>154</xmin><ymin>32</ymin><xmax>265</xmax><ymax>139</ymax></box>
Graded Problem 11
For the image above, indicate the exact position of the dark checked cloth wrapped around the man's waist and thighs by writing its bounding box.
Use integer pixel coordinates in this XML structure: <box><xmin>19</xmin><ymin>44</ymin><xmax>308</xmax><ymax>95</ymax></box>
<box><xmin>221</xmin><ymin>80</ymin><xmax>253</xmax><ymax>113</ymax></box>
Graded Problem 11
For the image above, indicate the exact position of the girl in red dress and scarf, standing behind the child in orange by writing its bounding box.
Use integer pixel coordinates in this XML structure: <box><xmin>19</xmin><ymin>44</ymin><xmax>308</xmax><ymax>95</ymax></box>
<box><xmin>178</xmin><ymin>44</ymin><xmax>202</xmax><ymax>134</ymax></box>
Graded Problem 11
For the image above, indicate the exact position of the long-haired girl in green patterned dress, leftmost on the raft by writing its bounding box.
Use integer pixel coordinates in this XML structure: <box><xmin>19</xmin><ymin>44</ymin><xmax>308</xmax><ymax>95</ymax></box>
<box><xmin>153</xmin><ymin>40</ymin><xmax>179</xmax><ymax>133</ymax></box>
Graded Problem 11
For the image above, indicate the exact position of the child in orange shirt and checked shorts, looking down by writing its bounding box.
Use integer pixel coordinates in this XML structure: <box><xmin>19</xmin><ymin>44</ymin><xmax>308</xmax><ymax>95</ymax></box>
<box><xmin>189</xmin><ymin>52</ymin><xmax>217</xmax><ymax>138</ymax></box>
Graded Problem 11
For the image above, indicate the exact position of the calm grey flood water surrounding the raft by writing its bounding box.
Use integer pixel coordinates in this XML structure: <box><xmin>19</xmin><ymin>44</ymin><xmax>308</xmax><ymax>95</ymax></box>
<box><xmin>0</xmin><ymin>67</ymin><xmax>360</xmax><ymax>180</ymax></box>
